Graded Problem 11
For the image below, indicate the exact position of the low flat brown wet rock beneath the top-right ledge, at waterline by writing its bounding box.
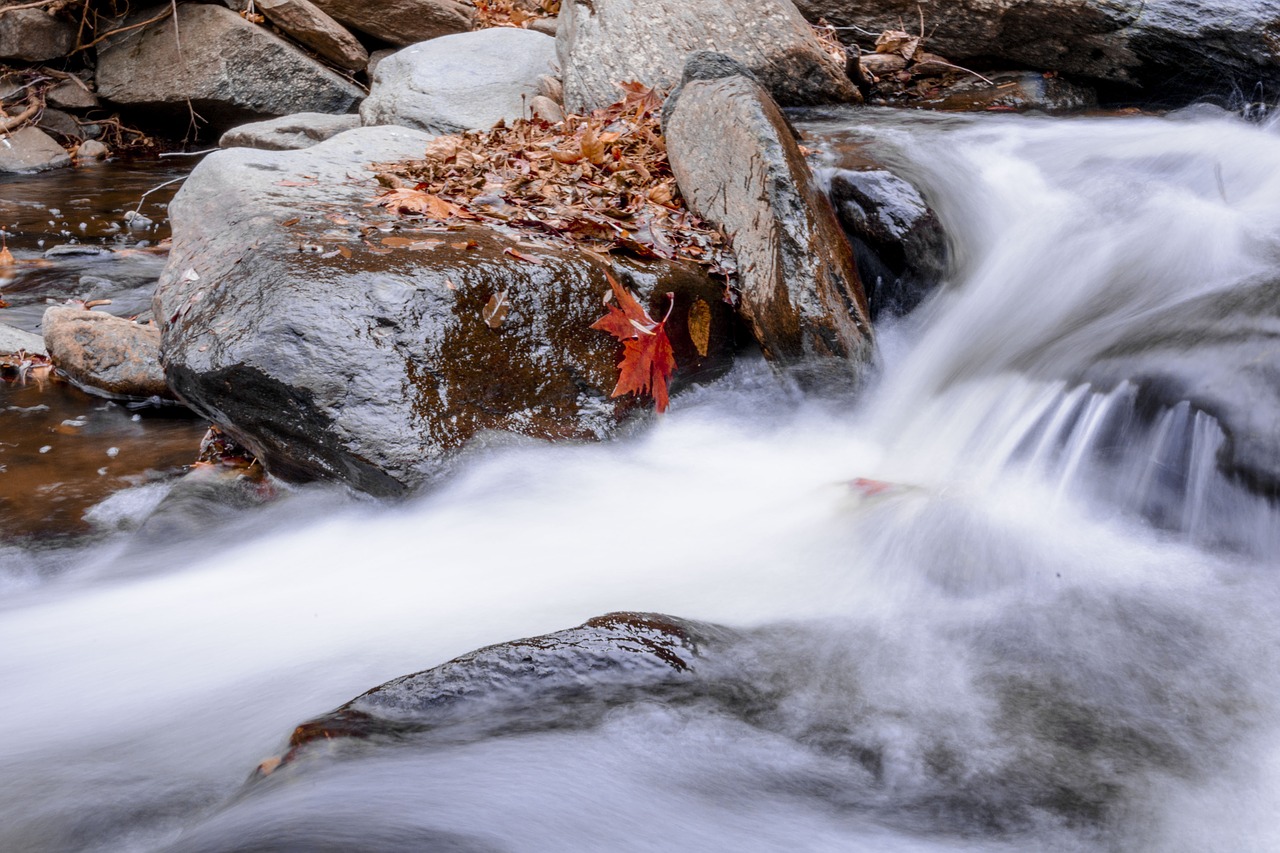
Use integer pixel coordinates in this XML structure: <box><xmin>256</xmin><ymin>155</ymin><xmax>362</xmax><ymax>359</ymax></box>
<box><xmin>911</xmin><ymin>72</ymin><xmax>1098</xmax><ymax>114</ymax></box>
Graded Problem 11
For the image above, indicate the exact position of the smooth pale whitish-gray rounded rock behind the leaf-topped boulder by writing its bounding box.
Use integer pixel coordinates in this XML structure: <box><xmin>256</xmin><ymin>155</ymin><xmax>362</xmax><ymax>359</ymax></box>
<box><xmin>360</xmin><ymin>27</ymin><xmax>556</xmax><ymax>133</ymax></box>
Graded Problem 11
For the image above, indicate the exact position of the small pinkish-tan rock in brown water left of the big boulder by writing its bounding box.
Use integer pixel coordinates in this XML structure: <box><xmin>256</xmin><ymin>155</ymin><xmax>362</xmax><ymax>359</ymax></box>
<box><xmin>41</xmin><ymin>306</ymin><xmax>173</xmax><ymax>400</ymax></box>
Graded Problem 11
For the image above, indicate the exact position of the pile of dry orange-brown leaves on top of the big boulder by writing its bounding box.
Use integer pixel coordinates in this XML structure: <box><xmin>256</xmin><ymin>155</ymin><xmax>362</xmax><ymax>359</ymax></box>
<box><xmin>374</xmin><ymin>83</ymin><xmax>735</xmax><ymax>279</ymax></box>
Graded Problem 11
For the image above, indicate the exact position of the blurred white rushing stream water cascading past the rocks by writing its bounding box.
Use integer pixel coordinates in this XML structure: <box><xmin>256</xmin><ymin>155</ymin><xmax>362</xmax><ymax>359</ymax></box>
<box><xmin>0</xmin><ymin>113</ymin><xmax>1280</xmax><ymax>852</ymax></box>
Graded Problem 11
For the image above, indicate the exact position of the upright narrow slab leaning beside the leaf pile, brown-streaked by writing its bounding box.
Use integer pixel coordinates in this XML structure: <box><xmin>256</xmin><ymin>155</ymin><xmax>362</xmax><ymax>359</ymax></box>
<box><xmin>663</xmin><ymin>54</ymin><xmax>872</xmax><ymax>375</ymax></box>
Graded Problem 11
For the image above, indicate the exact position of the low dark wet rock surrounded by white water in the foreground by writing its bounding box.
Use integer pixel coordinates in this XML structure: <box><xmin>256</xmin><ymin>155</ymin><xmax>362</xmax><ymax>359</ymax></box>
<box><xmin>281</xmin><ymin>612</ymin><xmax>733</xmax><ymax>758</ymax></box>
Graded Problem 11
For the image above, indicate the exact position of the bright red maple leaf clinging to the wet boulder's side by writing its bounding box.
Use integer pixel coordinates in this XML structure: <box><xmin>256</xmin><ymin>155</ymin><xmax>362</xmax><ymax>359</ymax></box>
<box><xmin>591</xmin><ymin>272</ymin><xmax>676</xmax><ymax>411</ymax></box>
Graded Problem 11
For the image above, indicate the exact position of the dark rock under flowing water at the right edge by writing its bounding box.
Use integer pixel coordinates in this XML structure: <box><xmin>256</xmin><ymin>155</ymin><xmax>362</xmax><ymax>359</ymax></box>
<box><xmin>1078</xmin><ymin>279</ymin><xmax>1280</xmax><ymax>494</ymax></box>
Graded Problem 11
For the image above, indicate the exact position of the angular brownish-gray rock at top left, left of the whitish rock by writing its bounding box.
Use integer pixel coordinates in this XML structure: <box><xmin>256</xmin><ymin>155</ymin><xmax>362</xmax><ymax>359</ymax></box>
<box><xmin>97</xmin><ymin>4</ymin><xmax>364</xmax><ymax>131</ymax></box>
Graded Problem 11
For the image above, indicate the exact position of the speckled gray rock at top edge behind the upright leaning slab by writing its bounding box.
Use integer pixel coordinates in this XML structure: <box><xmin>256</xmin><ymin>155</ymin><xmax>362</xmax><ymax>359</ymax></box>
<box><xmin>556</xmin><ymin>0</ymin><xmax>860</xmax><ymax>113</ymax></box>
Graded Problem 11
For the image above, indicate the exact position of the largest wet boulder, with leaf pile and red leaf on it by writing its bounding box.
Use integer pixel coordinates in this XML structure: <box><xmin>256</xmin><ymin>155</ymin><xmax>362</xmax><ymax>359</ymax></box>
<box><xmin>155</xmin><ymin>127</ymin><xmax>733</xmax><ymax>496</ymax></box>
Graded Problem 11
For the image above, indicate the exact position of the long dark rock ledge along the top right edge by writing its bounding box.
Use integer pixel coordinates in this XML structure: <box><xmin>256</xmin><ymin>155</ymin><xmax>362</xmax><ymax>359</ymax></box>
<box><xmin>796</xmin><ymin>0</ymin><xmax>1280</xmax><ymax>96</ymax></box>
